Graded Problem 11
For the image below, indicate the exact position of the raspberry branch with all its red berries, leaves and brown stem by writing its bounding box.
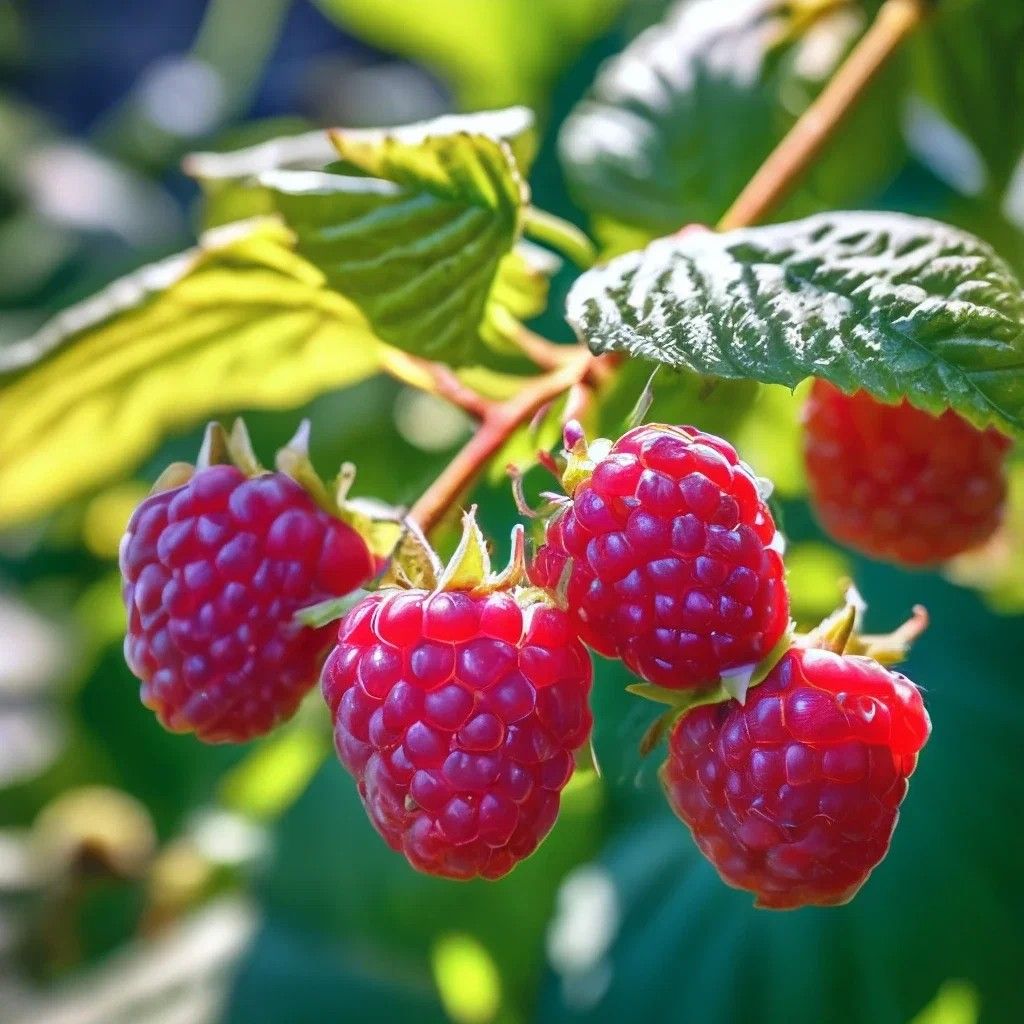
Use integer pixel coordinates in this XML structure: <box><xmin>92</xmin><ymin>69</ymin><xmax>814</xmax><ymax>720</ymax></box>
<box><xmin>0</xmin><ymin>0</ymin><xmax>1024</xmax><ymax>1019</ymax></box>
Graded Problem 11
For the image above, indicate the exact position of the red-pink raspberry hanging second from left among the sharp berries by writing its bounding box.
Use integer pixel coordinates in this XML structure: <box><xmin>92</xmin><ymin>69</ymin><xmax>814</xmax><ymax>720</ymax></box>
<box><xmin>323</xmin><ymin>590</ymin><xmax>591</xmax><ymax>879</ymax></box>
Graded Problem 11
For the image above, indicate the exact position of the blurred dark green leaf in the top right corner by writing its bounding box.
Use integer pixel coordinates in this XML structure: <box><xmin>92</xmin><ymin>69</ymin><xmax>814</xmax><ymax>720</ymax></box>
<box><xmin>910</xmin><ymin>0</ymin><xmax>1024</xmax><ymax>196</ymax></box>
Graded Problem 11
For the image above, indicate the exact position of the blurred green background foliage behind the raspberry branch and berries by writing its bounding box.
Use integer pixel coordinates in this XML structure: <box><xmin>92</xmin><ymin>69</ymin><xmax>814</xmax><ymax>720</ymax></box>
<box><xmin>0</xmin><ymin>0</ymin><xmax>1024</xmax><ymax>1024</ymax></box>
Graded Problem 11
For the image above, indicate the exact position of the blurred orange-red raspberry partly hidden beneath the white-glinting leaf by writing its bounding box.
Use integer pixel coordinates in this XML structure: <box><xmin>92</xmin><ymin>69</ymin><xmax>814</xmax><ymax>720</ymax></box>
<box><xmin>804</xmin><ymin>380</ymin><xmax>1010</xmax><ymax>565</ymax></box>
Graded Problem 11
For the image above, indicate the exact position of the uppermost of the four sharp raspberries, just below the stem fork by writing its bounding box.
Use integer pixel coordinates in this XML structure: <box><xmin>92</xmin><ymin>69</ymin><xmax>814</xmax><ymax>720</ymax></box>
<box><xmin>530</xmin><ymin>425</ymin><xmax>790</xmax><ymax>689</ymax></box>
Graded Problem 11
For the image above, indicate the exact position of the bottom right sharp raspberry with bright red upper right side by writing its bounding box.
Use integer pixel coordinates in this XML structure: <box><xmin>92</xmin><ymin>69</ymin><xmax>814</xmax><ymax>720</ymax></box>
<box><xmin>662</xmin><ymin>648</ymin><xmax>931</xmax><ymax>910</ymax></box>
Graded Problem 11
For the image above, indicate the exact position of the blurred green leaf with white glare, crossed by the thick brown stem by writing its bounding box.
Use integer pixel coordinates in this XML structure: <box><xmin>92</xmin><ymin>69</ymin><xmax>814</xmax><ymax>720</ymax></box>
<box><xmin>560</xmin><ymin>0</ymin><xmax>902</xmax><ymax>252</ymax></box>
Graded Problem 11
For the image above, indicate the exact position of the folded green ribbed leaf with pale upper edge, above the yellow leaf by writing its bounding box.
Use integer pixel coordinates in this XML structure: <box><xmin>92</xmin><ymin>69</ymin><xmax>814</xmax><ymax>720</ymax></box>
<box><xmin>187</xmin><ymin>108</ymin><xmax>557</xmax><ymax>364</ymax></box>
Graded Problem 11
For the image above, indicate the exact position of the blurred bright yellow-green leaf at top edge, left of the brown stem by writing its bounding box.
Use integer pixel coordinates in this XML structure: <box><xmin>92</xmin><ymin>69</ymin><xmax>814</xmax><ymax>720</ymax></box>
<box><xmin>317</xmin><ymin>0</ymin><xmax>623</xmax><ymax>110</ymax></box>
